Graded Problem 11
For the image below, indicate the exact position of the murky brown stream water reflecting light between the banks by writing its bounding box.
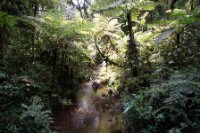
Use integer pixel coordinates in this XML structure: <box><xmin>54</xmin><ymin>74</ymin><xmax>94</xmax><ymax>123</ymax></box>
<box><xmin>54</xmin><ymin>69</ymin><xmax>123</xmax><ymax>133</ymax></box>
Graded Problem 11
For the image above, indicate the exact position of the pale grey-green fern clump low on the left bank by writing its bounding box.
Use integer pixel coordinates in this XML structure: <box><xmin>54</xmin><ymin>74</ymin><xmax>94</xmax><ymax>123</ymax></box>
<box><xmin>20</xmin><ymin>96</ymin><xmax>53</xmax><ymax>132</ymax></box>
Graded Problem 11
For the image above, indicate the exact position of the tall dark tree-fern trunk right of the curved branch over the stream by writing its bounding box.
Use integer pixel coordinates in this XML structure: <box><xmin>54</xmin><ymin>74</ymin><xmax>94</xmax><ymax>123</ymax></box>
<box><xmin>126</xmin><ymin>12</ymin><xmax>138</xmax><ymax>77</ymax></box>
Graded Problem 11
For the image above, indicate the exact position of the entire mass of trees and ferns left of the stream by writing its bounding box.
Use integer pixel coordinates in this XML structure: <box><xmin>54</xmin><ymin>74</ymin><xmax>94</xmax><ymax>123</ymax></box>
<box><xmin>0</xmin><ymin>0</ymin><xmax>93</xmax><ymax>133</ymax></box>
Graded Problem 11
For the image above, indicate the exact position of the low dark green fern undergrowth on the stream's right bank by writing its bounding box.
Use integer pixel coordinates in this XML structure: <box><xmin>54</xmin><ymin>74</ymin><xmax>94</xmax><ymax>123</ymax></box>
<box><xmin>124</xmin><ymin>69</ymin><xmax>200</xmax><ymax>132</ymax></box>
